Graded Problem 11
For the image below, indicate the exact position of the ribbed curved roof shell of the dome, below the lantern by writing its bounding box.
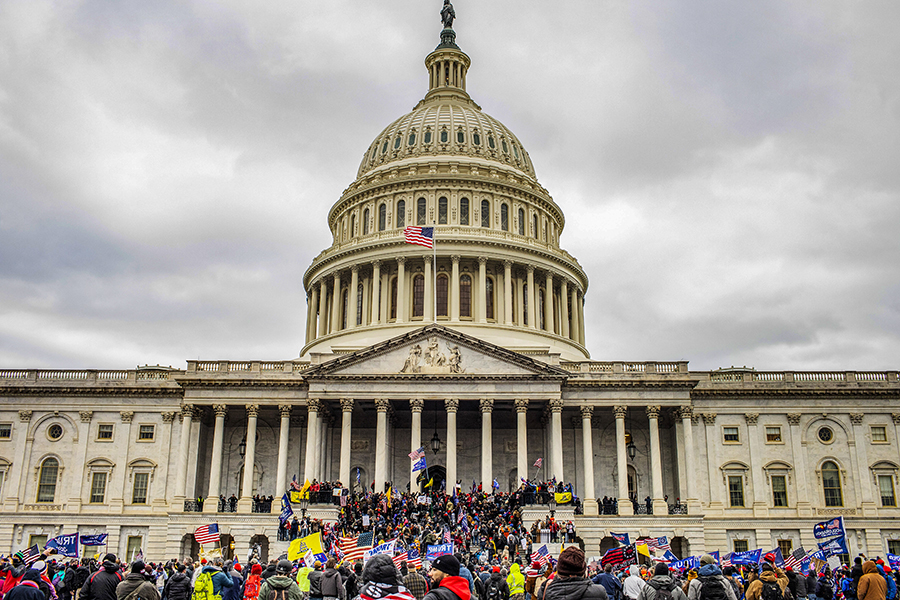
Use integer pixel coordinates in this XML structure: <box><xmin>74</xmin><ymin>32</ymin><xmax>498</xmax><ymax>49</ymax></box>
<box><xmin>357</xmin><ymin>98</ymin><xmax>535</xmax><ymax>178</ymax></box>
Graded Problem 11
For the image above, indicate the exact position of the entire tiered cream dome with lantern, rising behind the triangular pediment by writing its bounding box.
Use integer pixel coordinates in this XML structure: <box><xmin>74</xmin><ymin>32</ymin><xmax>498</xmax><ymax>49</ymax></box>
<box><xmin>301</xmin><ymin>27</ymin><xmax>588</xmax><ymax>362</ymax></box>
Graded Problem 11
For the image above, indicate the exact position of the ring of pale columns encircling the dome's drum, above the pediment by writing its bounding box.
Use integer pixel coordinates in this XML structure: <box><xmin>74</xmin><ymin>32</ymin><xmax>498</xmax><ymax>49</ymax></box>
<box><xmin>306</xmin><ymin>254</ymin><xmax>584</xmax><ymax>345</ymax></box>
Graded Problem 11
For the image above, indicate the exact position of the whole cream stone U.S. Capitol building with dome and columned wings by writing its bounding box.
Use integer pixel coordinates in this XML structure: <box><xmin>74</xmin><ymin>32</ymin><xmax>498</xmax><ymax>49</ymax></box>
<box><xmin>0</xmin><ymin>8</ymin><xmax>900</xmax><ymax>558</ymax></box>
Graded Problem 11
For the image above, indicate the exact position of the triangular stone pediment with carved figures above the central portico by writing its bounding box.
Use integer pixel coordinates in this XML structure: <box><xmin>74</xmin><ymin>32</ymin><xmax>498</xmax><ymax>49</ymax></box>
<box><xmin>304</xmin><ymin>325</ymin><xmax>568</xmax><ymax>379</ymax></box>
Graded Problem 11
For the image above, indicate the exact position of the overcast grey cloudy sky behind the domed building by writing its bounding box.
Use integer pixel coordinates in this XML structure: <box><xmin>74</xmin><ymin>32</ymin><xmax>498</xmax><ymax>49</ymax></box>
<box><xmin>0</xmin><ymin>0</ymin><xmax>900</xmax><ymax>370</ymax></box>
